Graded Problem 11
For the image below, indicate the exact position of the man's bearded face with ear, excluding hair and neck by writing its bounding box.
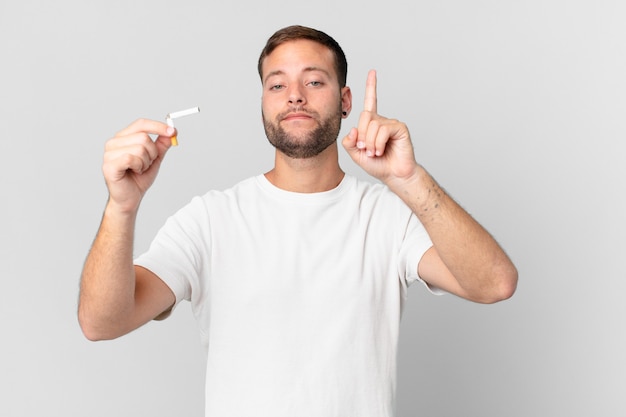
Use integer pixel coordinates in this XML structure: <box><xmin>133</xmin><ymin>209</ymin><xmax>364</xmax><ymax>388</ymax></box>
<box><xmin>262</xmin><ymin>40</ymin><xmax>349</xmax><ymax>158</ymax></box>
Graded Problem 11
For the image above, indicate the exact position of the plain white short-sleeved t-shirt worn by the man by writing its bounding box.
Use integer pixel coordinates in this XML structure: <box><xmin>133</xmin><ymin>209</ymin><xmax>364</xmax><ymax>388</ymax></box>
<box><xmin>136</xmin><ymin>175</ymin><xmax>431</xmax><ymax>417</ymax></box>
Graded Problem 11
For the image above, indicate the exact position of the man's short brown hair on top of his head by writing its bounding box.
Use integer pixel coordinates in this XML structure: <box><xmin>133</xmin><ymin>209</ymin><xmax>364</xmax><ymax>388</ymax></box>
<box><xmin>258</xmin><ymin>25</ymin><xmax>348</xmax><ymax>87</ymax></box>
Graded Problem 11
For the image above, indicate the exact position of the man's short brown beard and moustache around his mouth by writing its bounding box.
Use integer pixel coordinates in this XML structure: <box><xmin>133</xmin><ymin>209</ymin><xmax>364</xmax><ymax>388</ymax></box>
<box><xmin>263</xmin><ymin>103</ymin><xmax>341</xmax><ymax>159</ymax></box>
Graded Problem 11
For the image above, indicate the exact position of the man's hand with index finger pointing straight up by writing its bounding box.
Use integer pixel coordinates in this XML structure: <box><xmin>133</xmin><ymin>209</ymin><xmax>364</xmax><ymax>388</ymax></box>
<box><xmin>343</xmin><ymin>70</ymin><xmax>417</xmax><ymax>183</ymax></box>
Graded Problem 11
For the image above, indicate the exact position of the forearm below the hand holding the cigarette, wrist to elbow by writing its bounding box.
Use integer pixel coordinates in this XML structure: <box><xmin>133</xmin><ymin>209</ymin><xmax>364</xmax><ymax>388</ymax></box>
<box><xmin>78</xmin><ymin>202</ymin><xmax>136</xmax><ymax>339</ymax></box>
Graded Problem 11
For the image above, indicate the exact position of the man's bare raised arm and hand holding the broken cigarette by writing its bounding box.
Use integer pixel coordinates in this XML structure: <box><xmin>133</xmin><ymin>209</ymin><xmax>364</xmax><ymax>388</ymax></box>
<box><xmin>78</xmin><ymin>119</ymin><xmax>176</xmax><ymax>340</ymax></box>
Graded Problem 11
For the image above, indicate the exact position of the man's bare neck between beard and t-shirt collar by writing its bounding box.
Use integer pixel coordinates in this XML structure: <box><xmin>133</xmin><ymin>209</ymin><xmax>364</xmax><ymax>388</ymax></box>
<box><xmin>265</xmin><ymin>142</ymin><xmax>344</xmax><ymax>193</ymax></box>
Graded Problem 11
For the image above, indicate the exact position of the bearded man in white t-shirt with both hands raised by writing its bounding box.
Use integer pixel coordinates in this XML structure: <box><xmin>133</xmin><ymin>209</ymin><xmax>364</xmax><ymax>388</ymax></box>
<box><xmin>79</xmin><ymin>26</ymin><xmax>517</xmax><ymax>417</ymax></box>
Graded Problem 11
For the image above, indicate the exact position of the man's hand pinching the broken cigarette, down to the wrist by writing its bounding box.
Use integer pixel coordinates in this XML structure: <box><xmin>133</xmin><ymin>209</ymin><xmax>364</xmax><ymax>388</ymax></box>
<box><xmin>102</xmin><ymin>119</ymin><xmax>176</xmax><ymax>211</ymax></box>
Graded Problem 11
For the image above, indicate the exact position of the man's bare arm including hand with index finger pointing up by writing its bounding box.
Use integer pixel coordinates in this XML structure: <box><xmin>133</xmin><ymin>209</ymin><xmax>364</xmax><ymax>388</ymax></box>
<box><xmin>343</xmin><ymin>71</ymin><xmax>517</xmax><ymax>303</ymax></box>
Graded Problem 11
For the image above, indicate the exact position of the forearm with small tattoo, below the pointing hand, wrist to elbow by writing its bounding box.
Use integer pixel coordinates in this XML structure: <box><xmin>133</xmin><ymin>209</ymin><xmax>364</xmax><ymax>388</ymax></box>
<box><xmin>388</xmin><ymin>166</ymin><xmax>517</xmax><ymax>302</ymax></box>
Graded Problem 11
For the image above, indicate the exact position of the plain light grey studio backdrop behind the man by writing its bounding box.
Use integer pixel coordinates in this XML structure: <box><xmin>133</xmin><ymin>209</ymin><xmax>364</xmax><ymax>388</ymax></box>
<box><xmin>0</xmin><ymin>0</ymin><xmax>626</xmax><ymax>417</ymax></box>
